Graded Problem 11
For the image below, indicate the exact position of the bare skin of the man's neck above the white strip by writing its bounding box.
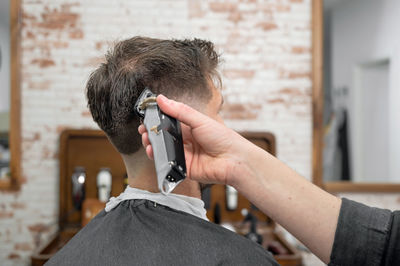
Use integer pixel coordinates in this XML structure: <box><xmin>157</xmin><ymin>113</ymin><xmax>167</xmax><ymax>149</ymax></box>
<box><xmin>123</xmin><ymin>153</ymin><xmax>201</xmax><ymax>199</ymax></box>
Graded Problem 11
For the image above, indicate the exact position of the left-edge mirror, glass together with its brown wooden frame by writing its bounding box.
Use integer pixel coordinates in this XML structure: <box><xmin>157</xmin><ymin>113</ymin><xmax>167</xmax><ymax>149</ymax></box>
<box><xmin>0</xmin><ymin>0</ymin><xmax>22</xmax><ymax>190</ymax></box>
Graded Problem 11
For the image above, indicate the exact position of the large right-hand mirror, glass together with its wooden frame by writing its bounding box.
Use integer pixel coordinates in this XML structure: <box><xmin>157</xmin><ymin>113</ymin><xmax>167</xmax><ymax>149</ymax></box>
<box><xmin>313</xmin><ymin>0</ymin><xmax>400</xmax><ymax>191</ymax></box>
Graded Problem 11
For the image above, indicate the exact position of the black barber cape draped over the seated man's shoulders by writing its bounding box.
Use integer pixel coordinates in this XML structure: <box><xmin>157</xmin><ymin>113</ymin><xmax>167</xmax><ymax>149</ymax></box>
<box><xmin>46</xmin><ymin>199</ymin><xmax>278</xmax><ymax>266</ymax></box>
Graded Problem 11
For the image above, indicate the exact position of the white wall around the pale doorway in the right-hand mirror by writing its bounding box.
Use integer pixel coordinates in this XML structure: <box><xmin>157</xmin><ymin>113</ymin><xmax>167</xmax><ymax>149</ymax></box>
<box><xmin>331</xmin><ymin>0</ymin><xmax>400</xmax><ymax>182</ymax></box>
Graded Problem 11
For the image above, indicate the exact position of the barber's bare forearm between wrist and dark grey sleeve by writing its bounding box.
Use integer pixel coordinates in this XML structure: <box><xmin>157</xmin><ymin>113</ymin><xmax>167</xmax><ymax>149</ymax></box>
<box><xmin>231</xmin><ymin>142</ymin><xmax>341</xmax><ymax>263</ymax></box>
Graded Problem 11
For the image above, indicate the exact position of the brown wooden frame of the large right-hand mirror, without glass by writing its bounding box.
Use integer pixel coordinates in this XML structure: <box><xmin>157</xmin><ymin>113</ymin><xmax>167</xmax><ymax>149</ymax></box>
<box><xmin>311</xmin><ymin>0</ymin><xmax>400</xmax><ymax>193</ymax></box>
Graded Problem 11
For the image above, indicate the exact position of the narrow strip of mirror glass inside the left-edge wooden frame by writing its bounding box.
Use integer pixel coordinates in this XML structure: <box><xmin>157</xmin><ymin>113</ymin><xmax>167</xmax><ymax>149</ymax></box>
<box><xmin>0</xmin><ymin>0</ymin><xmax>10</xmax><ymax>183</ymax></box>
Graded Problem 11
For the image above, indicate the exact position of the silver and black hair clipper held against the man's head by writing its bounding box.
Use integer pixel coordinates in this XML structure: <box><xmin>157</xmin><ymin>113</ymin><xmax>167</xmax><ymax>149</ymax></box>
<box><xmin>135</xmin><ymin>88</ymin><xmax>186</xmax><ymax>194</ymax></box>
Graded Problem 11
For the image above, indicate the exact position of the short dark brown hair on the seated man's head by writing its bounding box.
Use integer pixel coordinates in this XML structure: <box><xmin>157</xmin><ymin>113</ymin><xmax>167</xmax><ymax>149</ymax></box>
<box><xmin>86</xmin><ymin>37</ymin><xmax>219</xmax><ymax>154</ymax></box>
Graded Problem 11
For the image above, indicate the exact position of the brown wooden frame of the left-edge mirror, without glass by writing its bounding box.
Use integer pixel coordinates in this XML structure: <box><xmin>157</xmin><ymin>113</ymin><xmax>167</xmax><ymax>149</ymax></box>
<box><xmin>0</xmin><ymin>0</ymin><xmax>22</xmax><ymax>191</ymax></box>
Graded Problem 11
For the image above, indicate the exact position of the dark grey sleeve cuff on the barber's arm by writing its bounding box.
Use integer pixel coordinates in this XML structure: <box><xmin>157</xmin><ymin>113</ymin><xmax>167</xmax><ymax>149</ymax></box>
<box><xmin>329</xmin><ymin>198</ymin><xmax>393</xmax><ymax>266</ymax></box>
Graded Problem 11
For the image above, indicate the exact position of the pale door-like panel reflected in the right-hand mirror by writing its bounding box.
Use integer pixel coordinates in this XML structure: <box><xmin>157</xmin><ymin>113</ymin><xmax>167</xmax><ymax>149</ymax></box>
<box><xmin>354</xmin><ymin>61</ymin><xmax>390</xmax><ymax>182</ymax></box>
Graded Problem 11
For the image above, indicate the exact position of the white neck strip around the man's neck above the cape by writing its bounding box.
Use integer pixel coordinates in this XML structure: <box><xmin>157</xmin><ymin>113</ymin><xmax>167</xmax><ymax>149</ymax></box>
<box><xmin>105</xmin><ymin>186</ymin><xmax>208</xmax><ymax>221</ymax></box>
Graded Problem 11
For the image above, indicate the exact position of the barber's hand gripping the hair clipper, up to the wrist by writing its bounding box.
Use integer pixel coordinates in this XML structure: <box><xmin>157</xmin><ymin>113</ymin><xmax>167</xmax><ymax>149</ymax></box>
<box><xmin>139</xmin><ymin>95</ymin><xmax>251</xmax><ymax>184</ymax></box>
